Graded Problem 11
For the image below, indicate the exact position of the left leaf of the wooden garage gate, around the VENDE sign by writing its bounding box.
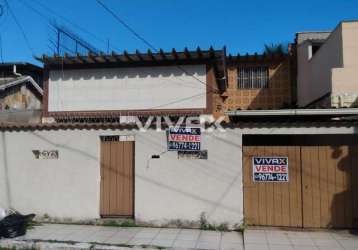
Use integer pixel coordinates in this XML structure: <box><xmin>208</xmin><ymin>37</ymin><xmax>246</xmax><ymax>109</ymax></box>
<box><xmin>243</xmin><ymin>146</ymin><xmax>302</xmax><ymax>227</ymax></box>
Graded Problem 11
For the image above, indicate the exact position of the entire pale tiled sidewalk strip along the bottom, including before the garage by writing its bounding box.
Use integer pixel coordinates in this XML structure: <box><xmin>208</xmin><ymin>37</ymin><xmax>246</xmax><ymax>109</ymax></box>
<box><xmin>0</xmin><ymin>224</ymin><xmax>358</xmax><ymax>250</ymax></box>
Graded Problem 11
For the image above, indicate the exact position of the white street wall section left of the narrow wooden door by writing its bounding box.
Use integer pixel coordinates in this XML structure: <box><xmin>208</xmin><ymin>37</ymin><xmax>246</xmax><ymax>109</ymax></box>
<box><xmin>0</xmin><ymin>131</ymin><xmax>100</xmax><ymax>218</ymax></box>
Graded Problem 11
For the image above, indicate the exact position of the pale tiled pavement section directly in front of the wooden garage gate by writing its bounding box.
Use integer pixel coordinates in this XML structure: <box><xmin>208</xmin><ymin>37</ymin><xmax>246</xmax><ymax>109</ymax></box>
<box><xmin>244</xmin><ymin>229</ymin><xmax>358</xmax><ymax>250</ymax></box>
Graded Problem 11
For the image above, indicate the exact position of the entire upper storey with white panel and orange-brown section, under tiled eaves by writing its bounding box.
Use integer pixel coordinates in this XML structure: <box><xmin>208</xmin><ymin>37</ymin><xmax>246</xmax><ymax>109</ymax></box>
<box><xmin>41</xmin><ymin>48</ymin><xmax>295</xmax><ymax>121</ymax></box>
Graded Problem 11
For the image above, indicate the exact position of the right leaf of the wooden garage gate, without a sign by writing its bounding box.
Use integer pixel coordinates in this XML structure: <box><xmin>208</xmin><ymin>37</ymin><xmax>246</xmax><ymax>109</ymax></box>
<box><xmin>301</xmin><ymin>145</ymin><xmax>358</xmax><ymax>228</ymax></box>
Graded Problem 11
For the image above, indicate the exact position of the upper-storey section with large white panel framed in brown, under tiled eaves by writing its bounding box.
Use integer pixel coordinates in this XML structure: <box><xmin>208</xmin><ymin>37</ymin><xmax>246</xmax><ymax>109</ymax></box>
<box><xmin>37</xmin><ymin>48</ymin><xmax>226</xmax><ymax>122</ymax></box>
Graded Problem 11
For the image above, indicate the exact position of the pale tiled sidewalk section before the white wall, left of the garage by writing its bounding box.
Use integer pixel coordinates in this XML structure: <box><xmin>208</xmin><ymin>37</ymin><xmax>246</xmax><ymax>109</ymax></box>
<box><xmin>0</xmin><ymin>224</ymin><xmax>243</xmax><ymax>250</ymax></box>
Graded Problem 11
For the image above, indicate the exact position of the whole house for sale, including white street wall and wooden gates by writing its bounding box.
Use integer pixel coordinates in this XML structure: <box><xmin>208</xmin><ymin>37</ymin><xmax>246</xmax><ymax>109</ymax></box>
<box><xmin>0</xmin><ymin>25</ymin><xmax>358</xmax><ymax>228</ymax></box>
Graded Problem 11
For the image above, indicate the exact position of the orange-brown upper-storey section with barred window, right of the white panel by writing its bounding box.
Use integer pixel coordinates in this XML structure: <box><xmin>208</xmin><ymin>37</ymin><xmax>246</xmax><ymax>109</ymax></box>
<box><xmin>214</xmin><ymin>54</ymin><xmax>294</xmax><ymax>116</ymax></box>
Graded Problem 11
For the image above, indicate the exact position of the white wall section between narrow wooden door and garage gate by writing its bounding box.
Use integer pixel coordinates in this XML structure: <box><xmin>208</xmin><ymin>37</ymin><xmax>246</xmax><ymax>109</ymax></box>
<box><xmin>135</xmin><ymin>132</ymin><xmax>243</xmax><ymax>225</ymax></box>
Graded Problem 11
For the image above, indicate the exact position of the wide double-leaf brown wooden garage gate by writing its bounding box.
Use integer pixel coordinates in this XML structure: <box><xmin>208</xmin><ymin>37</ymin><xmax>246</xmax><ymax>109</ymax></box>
<box><xmin>243</xmin><ymin>135</ymin><xmax>358</xmax><ymax>228</ymax></box>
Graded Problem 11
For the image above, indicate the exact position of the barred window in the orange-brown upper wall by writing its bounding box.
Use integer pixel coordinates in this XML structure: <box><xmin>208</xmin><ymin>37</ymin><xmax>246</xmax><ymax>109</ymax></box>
<box><xmin>237</xmin><ymin>66</ymin><xmax>269</xmax><ymax>89</ymax></box>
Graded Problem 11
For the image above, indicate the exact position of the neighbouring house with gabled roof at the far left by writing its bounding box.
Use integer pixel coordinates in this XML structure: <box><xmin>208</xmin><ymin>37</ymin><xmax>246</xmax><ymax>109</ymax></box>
<box><xmin>0</xmin><ymin>63</ymin><xmax>43</xmax><ymax>122</ymax></box>
